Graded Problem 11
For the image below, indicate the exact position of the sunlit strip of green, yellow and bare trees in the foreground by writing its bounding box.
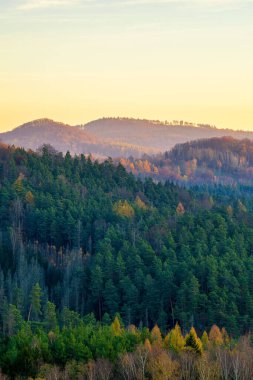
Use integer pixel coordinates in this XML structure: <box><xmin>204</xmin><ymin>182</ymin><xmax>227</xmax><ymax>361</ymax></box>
<box><xmin>0</xmin><ymin>312</ymin><xmax>253</xmax><ymax>380</ymax></box>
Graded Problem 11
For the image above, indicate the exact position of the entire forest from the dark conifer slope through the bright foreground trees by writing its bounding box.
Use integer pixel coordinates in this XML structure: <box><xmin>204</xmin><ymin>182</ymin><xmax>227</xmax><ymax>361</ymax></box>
<box><xmin>0</xmin><ymin>146</ymin><xmax>253</xmax><ymax>380</ymax></box>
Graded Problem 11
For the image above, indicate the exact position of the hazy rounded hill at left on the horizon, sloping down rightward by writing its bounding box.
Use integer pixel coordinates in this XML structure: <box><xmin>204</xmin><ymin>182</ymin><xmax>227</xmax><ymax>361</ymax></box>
<box><xmin>0</xmin><ymin>119</ymin><xmax>157</xmax><ymax>158</ymax></box>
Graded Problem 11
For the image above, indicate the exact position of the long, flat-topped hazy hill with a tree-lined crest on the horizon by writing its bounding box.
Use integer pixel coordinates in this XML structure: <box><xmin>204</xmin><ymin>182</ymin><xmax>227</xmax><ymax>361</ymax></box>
<box><xmin>80</xmin><ymin>118</ymin><xmax>253</xmax><ymax>153</ymax></box>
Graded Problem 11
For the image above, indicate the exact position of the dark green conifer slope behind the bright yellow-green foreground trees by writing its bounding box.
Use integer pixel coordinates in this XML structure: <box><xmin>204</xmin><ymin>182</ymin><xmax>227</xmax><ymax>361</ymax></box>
<box><xmin>0</xmin><ymin>147</ymin><xmax>253</xmax><ymax>334</ymax></box>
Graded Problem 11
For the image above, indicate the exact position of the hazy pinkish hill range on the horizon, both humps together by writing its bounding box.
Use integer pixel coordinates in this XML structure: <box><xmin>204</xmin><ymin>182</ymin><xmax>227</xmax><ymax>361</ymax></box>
<box><xmin>0</xmin><ymin>118</ymin><xmax>253</xmax><ymax>158</ymax></box>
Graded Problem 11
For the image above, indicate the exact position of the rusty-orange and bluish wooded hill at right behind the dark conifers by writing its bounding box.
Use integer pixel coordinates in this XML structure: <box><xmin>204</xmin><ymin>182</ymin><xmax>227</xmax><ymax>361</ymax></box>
<box><xmin>120</xmin><ymin>137</ymin><xmax>253</xmax><ymax>186</ymax></box>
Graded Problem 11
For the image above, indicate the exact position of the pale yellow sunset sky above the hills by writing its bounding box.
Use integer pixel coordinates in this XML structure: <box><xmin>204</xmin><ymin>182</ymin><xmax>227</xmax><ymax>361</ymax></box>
<box><xmin>0</xmin><ymin>0</ymin><xmax>253</xmax><ymax>131</ymax></box>
